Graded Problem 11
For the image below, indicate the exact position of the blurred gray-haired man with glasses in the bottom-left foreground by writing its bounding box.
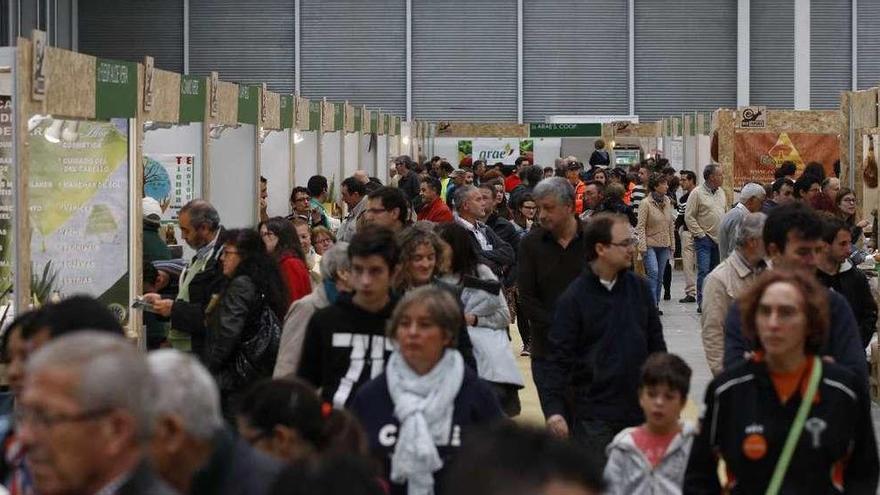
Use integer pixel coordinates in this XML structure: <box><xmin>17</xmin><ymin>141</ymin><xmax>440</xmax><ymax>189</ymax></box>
<box><xmin>16</xmin><ymin>331</ymin><xmax>174</xmax><ymax>495</ymax></box>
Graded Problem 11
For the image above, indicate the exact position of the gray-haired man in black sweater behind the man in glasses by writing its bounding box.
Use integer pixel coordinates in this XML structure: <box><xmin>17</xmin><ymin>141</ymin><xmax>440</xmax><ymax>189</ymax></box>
<box><xmin>517</xmin><ymin>177</ymin><xmax>587</xmax><ymax>410</ymax></box>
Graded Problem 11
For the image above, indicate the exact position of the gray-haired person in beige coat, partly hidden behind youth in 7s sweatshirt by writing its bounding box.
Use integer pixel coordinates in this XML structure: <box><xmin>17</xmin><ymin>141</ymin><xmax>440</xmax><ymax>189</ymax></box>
<box><xmin>272</xmin><ymin>242</ymin><xmax>352</xmax><ymax>378</ymax></box>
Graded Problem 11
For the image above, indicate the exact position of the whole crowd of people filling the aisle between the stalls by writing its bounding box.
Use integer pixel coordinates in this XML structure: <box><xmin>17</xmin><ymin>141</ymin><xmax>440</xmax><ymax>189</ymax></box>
<box><xmin>0</xmin><ymin>149</ymin><xmax>880</xmax><ymax>495</ymax></box>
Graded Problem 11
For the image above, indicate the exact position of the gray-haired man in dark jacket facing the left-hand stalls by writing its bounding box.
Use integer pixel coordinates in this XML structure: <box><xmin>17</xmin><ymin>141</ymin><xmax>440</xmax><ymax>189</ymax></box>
<box><xmin>144</xmin><ymin>199</ymin><xmax>223</xmax><ymax>356</ymax></box>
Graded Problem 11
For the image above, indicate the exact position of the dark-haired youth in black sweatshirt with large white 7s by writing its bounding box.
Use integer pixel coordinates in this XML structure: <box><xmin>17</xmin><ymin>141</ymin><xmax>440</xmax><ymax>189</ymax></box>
<box><xmin>297</xmin><ymin>225</ymin><xmax>400</xmax><ymax>408</ymax></box>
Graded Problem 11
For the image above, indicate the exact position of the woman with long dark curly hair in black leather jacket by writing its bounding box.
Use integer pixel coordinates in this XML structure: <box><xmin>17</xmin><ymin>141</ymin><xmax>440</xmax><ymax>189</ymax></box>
<box><xmin>204</xmin><ymin>229</ymin><xmax>287</xmax><ymax>419</ymax></box>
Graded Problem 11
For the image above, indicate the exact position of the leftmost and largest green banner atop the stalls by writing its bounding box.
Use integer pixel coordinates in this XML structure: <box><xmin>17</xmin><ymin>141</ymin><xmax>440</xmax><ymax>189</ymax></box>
<box><xmin>95</xmin><ymin>58</ymin><xmax>138</xmax><ymax>120</ymax></box>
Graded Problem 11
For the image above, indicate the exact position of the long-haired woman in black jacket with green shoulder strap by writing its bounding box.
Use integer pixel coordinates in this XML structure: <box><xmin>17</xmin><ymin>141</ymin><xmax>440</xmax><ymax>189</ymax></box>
<box><xmin>683</xmin><ymin>270</ymin><xmax>878</xmax><ymax>494</ymax></box>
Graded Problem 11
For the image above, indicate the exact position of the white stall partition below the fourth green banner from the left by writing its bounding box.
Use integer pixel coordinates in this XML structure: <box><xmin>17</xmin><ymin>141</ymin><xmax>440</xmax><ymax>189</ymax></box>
<box><xmin>260</xmin><ymin>129</ymin><xmax>293</xmax><ymax>217</ymax></box>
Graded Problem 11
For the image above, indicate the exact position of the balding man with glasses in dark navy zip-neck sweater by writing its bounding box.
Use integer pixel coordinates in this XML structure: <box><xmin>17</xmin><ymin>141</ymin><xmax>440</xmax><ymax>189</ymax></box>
<box><xmin>544</xmin><ymin>214</ymin><xmax>666</xmax><ymax>460</ymax></box>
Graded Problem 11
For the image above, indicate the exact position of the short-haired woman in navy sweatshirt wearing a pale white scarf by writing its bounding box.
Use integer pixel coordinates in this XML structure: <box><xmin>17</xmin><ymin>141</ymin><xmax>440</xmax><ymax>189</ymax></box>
<box><xmin>351</xmin><ymin>286</ymin><xmax>504</xmax><ymax>495</ymax></box>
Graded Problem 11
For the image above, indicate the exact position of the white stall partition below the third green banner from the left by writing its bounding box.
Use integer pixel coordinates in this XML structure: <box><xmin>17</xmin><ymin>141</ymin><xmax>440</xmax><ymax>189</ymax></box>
<box><xmin>208</xmin><ymin>124</ymin><xmax>259</xmax><ymax>228</ymax></box>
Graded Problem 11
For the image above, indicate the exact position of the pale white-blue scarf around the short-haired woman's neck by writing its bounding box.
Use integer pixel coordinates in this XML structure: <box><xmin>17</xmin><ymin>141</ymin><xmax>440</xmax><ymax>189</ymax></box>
<box><xmin>385</xmin><ymin>349</ymin><xmax>464</xmax><ymax>495</ymax></box>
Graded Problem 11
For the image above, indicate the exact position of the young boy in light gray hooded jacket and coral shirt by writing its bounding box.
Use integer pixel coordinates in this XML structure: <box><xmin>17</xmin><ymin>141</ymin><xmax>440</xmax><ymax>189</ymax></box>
<box><xmin>605</xmin><ymin>352</ymin><xmax>696</xmax><ymax>495</ymax></box>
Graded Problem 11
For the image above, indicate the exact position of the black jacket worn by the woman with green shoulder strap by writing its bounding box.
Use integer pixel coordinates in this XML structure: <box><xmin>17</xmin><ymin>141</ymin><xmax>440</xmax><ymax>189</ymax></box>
<box><xmin>683</xmin><ymin>360</ymin><xmax>878</xmax><ymax>495</ymax></box>
